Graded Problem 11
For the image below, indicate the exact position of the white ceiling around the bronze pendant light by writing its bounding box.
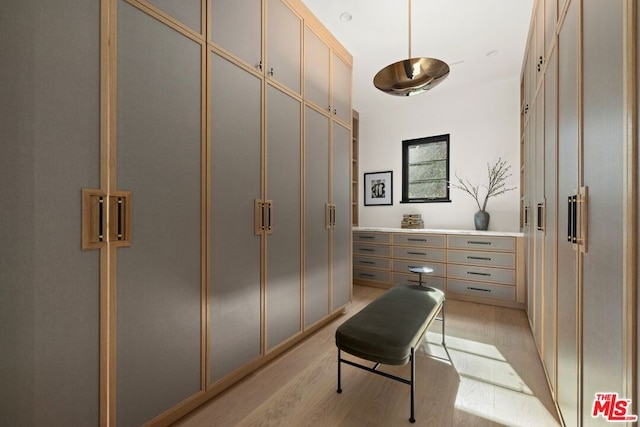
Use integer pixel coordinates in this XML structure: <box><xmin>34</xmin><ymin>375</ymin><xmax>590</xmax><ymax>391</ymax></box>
<box><xmin>302</xmin><ymin>0</ymin><xmax>534</xmax><ymax>111</ymax></box>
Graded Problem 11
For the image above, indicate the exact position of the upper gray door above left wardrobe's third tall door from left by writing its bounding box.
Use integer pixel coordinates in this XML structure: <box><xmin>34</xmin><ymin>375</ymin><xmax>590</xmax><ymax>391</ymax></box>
<box><xmin>210</xmin><ymin>0</ymin><xmax>262</xmax><ymax>67</ymax></box>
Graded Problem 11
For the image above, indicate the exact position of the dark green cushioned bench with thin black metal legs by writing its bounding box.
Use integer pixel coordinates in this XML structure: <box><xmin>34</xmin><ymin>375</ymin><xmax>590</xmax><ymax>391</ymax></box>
<box><xmin>336</xmin><ymin>285</ymin><xmax>451</xmax><ymax>423</ymax></box>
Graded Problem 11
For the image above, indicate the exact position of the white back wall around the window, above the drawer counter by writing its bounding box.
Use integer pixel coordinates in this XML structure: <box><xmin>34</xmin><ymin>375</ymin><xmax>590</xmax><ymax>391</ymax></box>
<box><xmin>358</xmin><ymin>75</ymin><xmax>520</xmax><ymax>231</ymax></box>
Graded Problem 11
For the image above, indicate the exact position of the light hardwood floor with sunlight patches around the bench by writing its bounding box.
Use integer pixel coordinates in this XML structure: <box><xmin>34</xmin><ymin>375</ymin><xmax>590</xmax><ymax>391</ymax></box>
<box><xmin>175</xmin><ymin>286</ymin><xmax>559</xmax><ymax>427</ymax></box>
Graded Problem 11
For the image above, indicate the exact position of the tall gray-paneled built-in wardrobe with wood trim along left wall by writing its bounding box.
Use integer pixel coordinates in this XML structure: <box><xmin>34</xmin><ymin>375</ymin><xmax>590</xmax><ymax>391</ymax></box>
<box><xmin>0</xmin><ymin>0</ymin><xmax>352</xmax><ymax>426</ymax></box>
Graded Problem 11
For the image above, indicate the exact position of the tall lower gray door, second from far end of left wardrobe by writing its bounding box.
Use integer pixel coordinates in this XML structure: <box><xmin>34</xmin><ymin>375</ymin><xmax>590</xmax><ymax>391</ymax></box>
<box><xmin>304</xmin><ymin>107</ymin><xmax>329</xmax><ymax>326</ymax></box>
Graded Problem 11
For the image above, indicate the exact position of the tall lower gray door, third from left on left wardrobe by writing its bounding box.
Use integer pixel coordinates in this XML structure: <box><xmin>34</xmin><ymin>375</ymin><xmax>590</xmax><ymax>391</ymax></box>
<box><xmin>209</xmin><ymin>54</ymin><xmax>262</xmax><ymax>381</ymax></box>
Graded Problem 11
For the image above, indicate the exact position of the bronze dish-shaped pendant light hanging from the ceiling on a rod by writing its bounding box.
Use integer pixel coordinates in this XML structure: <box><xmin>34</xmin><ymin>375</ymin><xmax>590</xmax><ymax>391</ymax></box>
<box><xmin>373</xmin><ymin>0</ymin><xmax>449</xmax><ymax>96</ymax></box>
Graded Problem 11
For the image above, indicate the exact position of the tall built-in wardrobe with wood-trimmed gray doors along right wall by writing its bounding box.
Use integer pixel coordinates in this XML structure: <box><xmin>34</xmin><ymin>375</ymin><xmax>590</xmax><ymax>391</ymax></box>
<box><xmin>521</xmin><ymin>0</ymin><xmax>639</xmax><ymax>426</ymax></box>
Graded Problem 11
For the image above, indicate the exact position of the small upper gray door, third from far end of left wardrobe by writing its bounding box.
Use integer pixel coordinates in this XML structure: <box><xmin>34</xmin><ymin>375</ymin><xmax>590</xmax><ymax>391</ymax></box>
<box><xmin>265</xmin><ymin>0</ymin><xmax>302</xmax><ymax>93</ymax></box>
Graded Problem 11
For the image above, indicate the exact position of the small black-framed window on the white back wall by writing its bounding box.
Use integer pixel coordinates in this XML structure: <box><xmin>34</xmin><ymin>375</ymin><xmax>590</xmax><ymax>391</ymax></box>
<box><xmin>401</xmin><ymin>134</ymin><xmax>451</xmax><ymax>203</ymax></box>
